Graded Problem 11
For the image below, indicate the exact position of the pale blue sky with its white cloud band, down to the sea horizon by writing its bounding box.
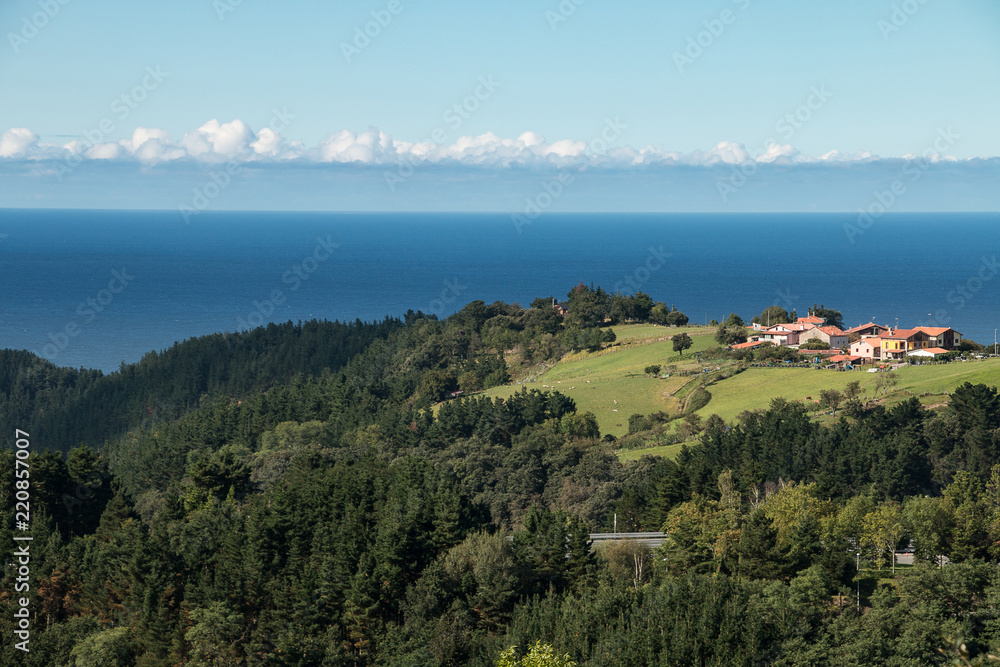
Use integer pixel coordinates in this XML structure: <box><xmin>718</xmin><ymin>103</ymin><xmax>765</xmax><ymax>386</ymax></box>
<box><xmin>0</xmin><ymin>0</ymin><xmax>1000</xmax><ymax>211</ymax></box>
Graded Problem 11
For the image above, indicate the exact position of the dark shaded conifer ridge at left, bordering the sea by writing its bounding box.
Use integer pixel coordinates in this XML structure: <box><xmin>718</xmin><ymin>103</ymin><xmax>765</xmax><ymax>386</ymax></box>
<box><xmin>0</xmin><ymin>318</ymin><xmax>403</xmax><ymax>452</ymax></box>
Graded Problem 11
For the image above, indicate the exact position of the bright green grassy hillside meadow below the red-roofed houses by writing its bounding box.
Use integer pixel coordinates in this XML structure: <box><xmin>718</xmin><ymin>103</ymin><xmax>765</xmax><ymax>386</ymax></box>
<box><xmin>486</xmin><ymin>324</ymin><xmax>1000</xmax><ymax>460</ymax></box>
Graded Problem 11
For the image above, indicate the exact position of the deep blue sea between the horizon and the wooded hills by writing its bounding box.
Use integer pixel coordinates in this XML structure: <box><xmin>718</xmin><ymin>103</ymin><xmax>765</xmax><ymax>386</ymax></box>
<box><xmin>0</xmin><ymin>210</ymin><xmax>1000</xmax><ymax>371</ymax></box>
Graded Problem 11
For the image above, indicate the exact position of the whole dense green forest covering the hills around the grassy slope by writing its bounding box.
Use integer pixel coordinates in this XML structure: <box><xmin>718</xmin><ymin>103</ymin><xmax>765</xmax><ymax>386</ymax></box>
<box><xmin>0</xmin><ymin>284</ymin><xmax>1000</xmax><ymax>667</ymax></box>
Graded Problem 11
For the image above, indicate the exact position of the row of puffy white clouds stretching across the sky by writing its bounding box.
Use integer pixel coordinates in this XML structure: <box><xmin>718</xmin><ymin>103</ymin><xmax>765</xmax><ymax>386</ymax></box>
<box><xmin>0</xmin><ymin>120</ymin><xmax>984</xmax><ymax>169</ymax></box>
